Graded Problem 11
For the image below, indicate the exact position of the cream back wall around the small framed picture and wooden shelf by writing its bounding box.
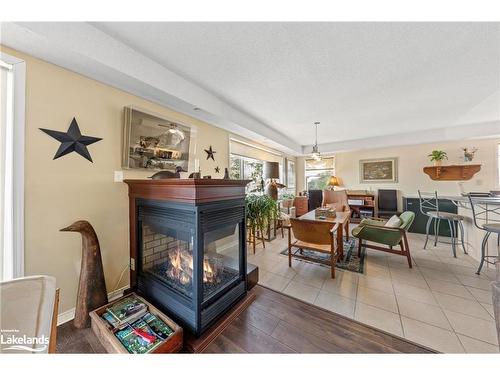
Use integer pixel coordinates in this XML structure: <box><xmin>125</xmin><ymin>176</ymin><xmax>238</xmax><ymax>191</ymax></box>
<box><xmin>297</xmin><ymin>139</ymin><xmax>499</xmax><ymax>210</ymax></box>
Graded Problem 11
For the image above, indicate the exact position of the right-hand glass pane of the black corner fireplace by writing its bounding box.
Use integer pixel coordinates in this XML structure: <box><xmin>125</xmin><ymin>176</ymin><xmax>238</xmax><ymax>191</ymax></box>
<box><xmin>203</xmin><ymin>223</ymin><xmax>244</xmax><ymax>302</ymax></box>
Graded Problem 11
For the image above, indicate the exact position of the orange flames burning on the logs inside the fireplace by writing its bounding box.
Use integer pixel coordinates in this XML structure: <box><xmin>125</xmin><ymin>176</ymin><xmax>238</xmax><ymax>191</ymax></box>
<box><xmin>167</xmin><ymin>248</ymin><xmax>217</xmax><ymax>285</ymax></box>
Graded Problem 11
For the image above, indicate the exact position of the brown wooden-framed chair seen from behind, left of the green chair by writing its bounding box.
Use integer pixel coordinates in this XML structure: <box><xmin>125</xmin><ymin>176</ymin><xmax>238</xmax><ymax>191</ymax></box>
<box><xmin>288</xmin><ymin>218</ymin><xmax>339</xmax><ymax>279</ymax></box>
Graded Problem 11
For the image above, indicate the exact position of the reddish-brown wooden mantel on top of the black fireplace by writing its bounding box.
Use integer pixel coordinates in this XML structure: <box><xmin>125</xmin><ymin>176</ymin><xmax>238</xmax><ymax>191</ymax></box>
<box><xmin>123</xmin><ymin>178</ymin><xmax>250</xmax><ymax>203</ymax></box>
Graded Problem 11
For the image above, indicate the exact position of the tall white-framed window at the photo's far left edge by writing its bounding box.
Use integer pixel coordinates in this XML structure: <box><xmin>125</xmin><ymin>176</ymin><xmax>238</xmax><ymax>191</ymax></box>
<box><xmin>0</xmin><ymin>53</ymin><xmax>25</xmax><ymax>280</ymax></box>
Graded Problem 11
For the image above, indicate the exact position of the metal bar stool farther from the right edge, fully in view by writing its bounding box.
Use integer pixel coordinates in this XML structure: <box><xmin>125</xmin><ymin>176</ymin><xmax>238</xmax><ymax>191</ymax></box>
<box><xmin>418</xmin><ymin>190</ymin><xmax>467</xmax><ymax>258</ymax></box>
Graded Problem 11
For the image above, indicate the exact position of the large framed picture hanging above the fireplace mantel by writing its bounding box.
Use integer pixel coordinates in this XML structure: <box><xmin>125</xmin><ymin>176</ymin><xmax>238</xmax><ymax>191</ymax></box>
<box><xmin>122</xmin><ymin>107</ymin><xmax>191</xmax><ymax>172</ymax></box>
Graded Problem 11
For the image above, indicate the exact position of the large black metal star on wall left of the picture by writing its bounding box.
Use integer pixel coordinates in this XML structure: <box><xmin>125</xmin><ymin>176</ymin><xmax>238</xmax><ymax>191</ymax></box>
<box><xmin>39</xmin><ymin>117</ymin><xmax>102</xmax><ymax>162</ymax></box>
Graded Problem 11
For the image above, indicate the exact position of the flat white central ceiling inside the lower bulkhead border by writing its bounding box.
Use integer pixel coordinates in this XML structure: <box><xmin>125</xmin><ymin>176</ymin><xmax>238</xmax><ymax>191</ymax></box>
<box><xmin>92</xmin><ymin>23</ymin><xmax>500</xmax><ymax>145</ymax></box>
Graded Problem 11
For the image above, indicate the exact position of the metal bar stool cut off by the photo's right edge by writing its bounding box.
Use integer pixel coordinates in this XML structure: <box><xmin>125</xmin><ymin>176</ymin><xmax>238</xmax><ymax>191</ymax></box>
<box><xmin>469</xmin><ymin>195</ymin><xmax>500</xmax><ymax>275</ymax></box>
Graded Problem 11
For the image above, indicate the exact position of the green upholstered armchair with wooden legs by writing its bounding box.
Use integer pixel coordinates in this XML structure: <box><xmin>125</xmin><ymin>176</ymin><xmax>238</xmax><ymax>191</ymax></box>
<box><xmin>352</xmin><ymin>211</ymin><xmax>415</xmax><ymax>268</ymax></box>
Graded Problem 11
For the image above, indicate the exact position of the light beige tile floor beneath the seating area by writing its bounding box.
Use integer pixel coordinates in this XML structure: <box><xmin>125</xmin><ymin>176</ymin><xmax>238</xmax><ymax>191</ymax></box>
<box><xmin>248</xmin><ymin>228</ymin><xmax>499</xmax><ymax>353</ymax></box>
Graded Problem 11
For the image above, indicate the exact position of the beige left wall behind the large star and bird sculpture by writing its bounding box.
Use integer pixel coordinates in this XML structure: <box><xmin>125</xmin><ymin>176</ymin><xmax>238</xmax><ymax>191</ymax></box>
<box><xmin>2</xmin><ymin>47</ymin><xmax>229</xmax><ymax>312</ymax></box>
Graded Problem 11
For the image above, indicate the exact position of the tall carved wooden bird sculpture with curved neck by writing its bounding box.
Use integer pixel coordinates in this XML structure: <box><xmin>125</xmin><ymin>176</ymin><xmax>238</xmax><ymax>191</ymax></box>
<box><xmin>61</xmin><ymin>220</ymin><xmax>108</xmax><ymax>328</ymax></box>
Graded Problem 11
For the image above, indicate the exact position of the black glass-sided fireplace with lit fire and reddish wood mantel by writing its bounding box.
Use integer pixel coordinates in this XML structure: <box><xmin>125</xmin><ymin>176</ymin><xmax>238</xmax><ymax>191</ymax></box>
<box><xmin>125</xmin><ymin>179</ymin><xmax>247</xmax><ymax>335</ymax></box>
